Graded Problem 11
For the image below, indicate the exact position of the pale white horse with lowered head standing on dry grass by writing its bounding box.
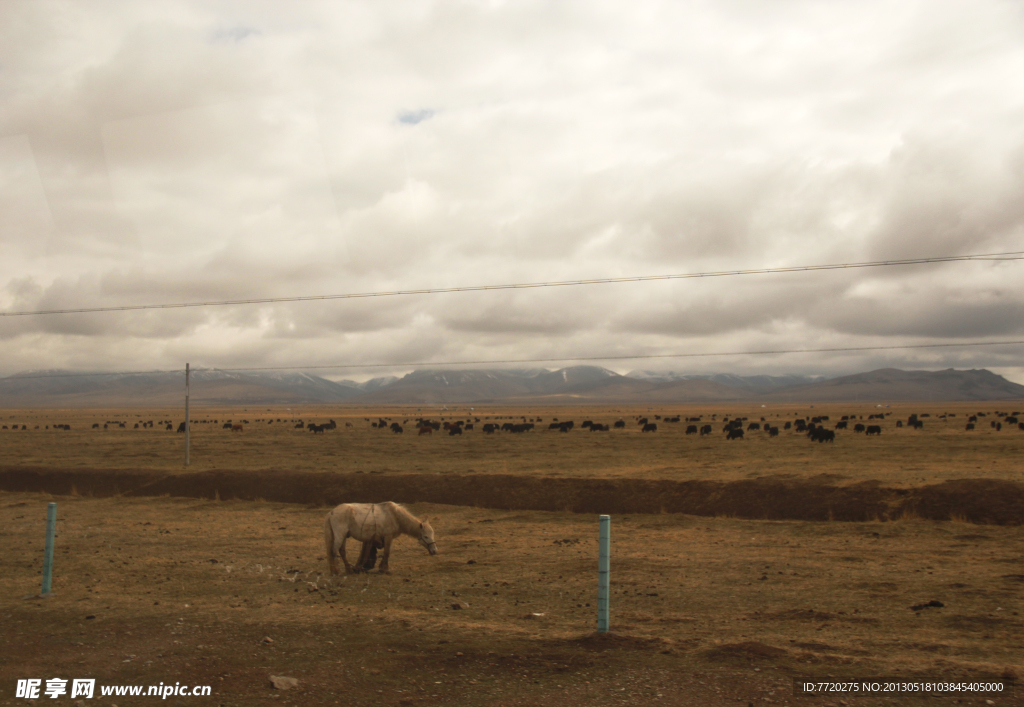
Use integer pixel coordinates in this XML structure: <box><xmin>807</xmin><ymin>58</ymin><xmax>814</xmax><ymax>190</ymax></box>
<box><xmin>324</xmin><ymin>501</ymin><xmax>437</xmax><ymax>575</ymax></box>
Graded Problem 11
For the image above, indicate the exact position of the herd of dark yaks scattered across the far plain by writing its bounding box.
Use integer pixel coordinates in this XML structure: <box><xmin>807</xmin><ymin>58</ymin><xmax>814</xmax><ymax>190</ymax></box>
<box><xmin>2</xmin><ymin>411</ymin><xmax>1024</xmax><ymax>443</ymax></box>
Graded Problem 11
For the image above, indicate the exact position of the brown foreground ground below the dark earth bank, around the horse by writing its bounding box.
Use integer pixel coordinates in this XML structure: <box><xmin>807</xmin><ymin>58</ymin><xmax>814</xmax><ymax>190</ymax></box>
<box><xmin>0</xmin><ymin>492</ymin><xmax>1024</xmax><ymax>707</ymax></box>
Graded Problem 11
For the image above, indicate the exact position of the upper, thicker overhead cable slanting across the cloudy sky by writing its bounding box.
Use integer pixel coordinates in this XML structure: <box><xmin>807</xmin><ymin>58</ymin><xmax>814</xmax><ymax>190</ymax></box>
<box><xmin>0</xmin><ymin>251</ymin><xmax>1024</xmax><ymax>317</ymax></box>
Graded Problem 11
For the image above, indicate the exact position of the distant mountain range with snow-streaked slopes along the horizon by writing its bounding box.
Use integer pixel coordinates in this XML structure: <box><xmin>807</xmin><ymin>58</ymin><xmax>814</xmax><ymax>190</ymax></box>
<box><xmin>0</xmin><ymin>366</ymin><xmax>1024</xmax><ymax>408</ymax></box>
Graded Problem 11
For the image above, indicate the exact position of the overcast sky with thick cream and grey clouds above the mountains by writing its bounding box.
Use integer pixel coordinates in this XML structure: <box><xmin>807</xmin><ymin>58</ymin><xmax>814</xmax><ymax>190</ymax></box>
<box><xmin>0</xmin><ymin>0</ymin><xmax>1024</xmax><ymax>382</ymax></box>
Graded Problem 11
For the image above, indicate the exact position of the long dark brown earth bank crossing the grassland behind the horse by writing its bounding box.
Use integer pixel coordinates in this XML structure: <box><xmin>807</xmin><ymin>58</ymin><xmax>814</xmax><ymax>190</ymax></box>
<box><xmin>0</xmin><ymin>467</ymin><xmax>1024</xmax><ymax>525</ymax></box>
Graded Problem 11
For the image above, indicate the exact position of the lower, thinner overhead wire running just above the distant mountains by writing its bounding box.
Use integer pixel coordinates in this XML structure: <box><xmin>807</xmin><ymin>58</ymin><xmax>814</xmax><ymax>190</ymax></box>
<box><xmin>0</xmin><ymin>339</ymin><xmax>1024</xmax><ymax>382</ymax></box>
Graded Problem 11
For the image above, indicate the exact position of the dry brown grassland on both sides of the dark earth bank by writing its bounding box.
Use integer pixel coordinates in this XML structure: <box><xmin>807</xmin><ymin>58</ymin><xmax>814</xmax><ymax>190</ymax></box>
<box><xmin>0</xmin><ymin>403</ymin><xmax>1024</xmax><ymax>707</ymax></box>
